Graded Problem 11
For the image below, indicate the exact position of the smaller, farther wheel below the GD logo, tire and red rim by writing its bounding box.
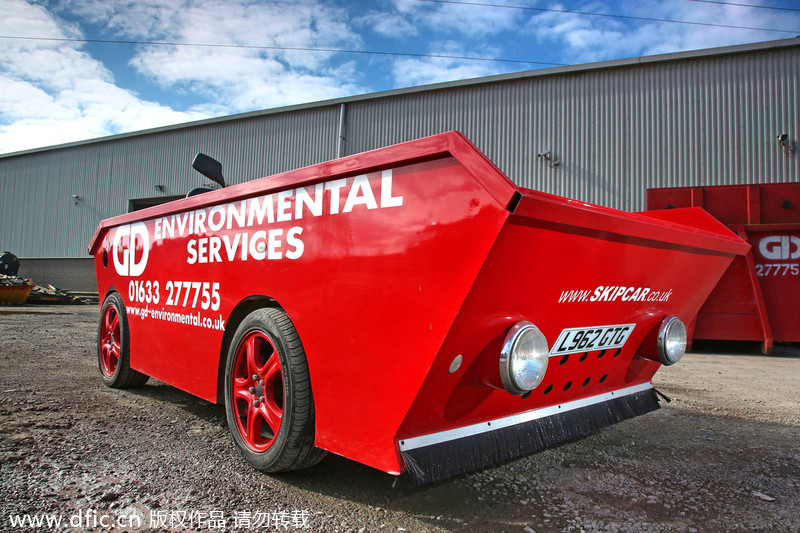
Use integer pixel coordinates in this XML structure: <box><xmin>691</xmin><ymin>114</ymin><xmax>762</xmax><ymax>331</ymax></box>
<box><xmin>97</xmin><ymin>292</ymin><xmax>150</xmax><ymax>389</ymax></box>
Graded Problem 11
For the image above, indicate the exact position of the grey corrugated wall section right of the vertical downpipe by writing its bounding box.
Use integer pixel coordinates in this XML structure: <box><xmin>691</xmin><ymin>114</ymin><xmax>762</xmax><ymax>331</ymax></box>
<box><xmin>346</xmin><ymin>48</ymin><xmax>800</xmax><ymax>210</ymax></box>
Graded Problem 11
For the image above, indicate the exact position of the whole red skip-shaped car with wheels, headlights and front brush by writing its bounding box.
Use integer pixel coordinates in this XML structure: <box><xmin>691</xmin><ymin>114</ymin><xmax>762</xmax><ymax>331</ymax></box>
<box><xmin>89</xmin><ymin>132</ymin><xmax>749</xmax><ymax>482</ymax></box>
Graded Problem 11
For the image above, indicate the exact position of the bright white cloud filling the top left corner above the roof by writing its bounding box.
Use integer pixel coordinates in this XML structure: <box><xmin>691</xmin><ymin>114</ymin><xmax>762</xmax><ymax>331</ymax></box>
<box><xmin>0</xmin><ymin>0</ymin><xmax>204</xmax><ymax>153</ymax></box>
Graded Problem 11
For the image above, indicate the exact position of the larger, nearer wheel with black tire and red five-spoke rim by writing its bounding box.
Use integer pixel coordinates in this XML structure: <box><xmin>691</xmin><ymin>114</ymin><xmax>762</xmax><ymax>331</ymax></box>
<box><xmin>225</xmin><ymin>308</ymin><xmax>326</xmax><ymax>472</ymax></box>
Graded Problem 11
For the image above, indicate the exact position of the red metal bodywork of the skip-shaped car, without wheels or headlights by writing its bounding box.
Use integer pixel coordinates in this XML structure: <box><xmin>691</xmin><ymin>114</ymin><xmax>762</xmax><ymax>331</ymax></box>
<box><xmin>90</xmin><ymin>132</ymin><xmax>748</xmax><ymax>473</ymax></box>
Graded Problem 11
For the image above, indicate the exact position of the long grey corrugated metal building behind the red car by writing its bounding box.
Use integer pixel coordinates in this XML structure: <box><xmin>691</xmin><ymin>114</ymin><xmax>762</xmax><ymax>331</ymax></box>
<box><xmin>0</xmin><ymin>38</ymin><xmax>800</xmax><ymax>290</ymax></box>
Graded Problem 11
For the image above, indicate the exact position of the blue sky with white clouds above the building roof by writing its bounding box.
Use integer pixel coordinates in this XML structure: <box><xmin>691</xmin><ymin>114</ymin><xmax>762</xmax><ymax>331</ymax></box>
<box><xmin>0</xmin><ymin>0</ymin><xmax>800</xmax><ymax>154</ymax></box>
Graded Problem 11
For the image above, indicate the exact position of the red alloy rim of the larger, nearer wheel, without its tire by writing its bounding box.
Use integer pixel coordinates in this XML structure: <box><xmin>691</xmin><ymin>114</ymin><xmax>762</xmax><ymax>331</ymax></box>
<box><xmin>231</xmin><ymin>330</ymin><xmax>284</xmax><ymax>453</ymax></box>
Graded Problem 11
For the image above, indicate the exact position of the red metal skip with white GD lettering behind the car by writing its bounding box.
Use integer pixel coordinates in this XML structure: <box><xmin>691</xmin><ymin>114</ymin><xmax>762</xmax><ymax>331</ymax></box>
<box><xmin>647</xmin><ymin>183</ymin><xmax>800</xmax><ymax>353</ymax></box>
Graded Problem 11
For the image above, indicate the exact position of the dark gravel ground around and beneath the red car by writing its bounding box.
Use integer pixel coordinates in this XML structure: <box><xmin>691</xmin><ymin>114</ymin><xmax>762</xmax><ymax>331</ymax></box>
<box><xmin>0</xmin><ymin>306</ymin><xmax>800</xmax><ymax>532</ymax></box>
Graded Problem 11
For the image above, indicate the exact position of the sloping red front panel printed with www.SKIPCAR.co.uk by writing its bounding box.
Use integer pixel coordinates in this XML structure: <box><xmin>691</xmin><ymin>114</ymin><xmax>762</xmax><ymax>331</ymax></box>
<box><xmin>400</xmin><ymin>205</ymin><xmax>741</xmax><ymax>438</ymax></box>
